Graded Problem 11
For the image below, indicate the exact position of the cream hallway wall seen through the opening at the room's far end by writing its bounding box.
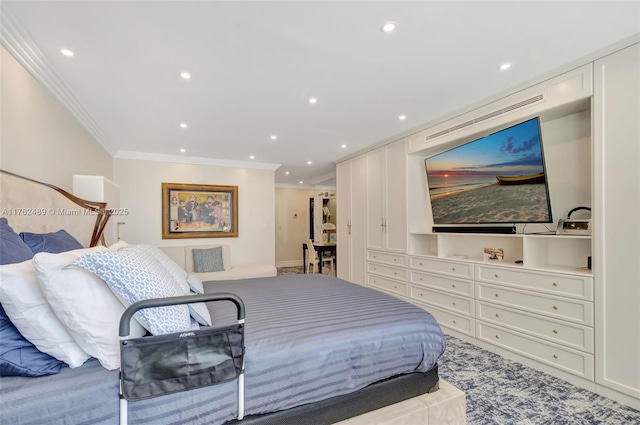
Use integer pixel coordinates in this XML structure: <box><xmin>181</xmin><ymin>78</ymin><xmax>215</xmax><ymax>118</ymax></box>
<box><xmin>275</xmin><ymin>188</ymin><xmax>315</xmax><ymax>267</ymax></box>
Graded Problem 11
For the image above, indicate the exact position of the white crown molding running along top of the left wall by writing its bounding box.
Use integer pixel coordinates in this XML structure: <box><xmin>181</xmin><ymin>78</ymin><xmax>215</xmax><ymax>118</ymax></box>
<box><xmin>0</xmin><ymin>7</ymin><xmax>113</xmax><ymax>155</ymax></box>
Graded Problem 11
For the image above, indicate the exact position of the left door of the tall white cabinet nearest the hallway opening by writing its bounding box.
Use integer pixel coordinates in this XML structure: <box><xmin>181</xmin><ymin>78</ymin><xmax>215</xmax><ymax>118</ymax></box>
<box><xmin>336</xmin><ymin>161</ymin><xmax>353</xmax><ymax>281</ymax></box>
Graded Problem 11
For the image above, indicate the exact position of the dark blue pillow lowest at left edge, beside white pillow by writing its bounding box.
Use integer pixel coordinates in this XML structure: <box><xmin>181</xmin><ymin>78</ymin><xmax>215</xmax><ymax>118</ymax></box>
<box><xmin>0</xmin><ymin>306</ymin><xmax>62</xmax><ymax>377</ymax></box>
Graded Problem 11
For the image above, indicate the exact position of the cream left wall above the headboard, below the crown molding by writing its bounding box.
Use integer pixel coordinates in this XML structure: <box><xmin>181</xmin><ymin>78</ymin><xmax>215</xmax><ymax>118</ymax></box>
<box><xmin>0</xmin><ymin>46</ymin><xmax>113</xmax><ymax>192</ymax></box>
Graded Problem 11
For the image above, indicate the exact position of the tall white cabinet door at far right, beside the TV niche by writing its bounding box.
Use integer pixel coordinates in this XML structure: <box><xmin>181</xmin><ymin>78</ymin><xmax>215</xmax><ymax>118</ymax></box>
<box><xmin>593</xmin><ymin>44</ymin><xmax>640</xmax><ymax>399</ymax></box>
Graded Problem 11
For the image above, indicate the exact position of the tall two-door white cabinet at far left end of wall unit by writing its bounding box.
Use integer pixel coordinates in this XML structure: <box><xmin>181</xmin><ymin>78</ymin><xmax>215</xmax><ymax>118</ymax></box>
<box><xmin>336</xmin><ymin>156</ymin><xmax>366</xmax><ymax>285</ymax></box>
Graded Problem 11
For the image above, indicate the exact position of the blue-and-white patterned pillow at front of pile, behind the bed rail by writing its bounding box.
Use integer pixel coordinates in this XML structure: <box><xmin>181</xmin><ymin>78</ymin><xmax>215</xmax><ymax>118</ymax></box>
<box><xmin>67</xmin><ymin>249</ymin><xmax>192</xmax><ymax>335</ymax></box>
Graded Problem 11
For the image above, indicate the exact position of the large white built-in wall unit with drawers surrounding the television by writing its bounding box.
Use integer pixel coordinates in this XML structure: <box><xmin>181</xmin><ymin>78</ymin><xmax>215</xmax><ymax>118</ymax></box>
<box><xmin>338</xmin><ymin>40</ymin><xmax>640</xmax><ymax>409</ymax></box>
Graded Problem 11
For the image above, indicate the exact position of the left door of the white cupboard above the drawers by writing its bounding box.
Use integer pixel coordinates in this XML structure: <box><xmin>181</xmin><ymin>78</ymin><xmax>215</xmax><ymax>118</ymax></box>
<box><xmin>366</xmin><ymin>149</ymin><xmax>385</xmax><ymax>249</ymax></box>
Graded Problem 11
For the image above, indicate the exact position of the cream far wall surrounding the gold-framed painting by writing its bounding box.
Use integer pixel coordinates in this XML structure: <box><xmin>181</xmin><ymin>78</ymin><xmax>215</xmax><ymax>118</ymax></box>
<box><xmin>113</xmin><ymin>158</ymin><xmax>275</xmax><ymax>265</ymax></box>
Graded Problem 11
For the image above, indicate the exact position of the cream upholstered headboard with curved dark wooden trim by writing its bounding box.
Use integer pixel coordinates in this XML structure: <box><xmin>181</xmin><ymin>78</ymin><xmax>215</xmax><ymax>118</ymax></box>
<box><xmin>0</xmin><ymin>170</ymin><xmax>111</xmax><ymax>247</ymax></box>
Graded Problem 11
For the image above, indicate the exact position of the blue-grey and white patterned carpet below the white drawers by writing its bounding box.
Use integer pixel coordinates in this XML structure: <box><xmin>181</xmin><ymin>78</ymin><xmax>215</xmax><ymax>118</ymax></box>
<box><xmin>438</xmin><ymin>336</ymin><xmax>640</xmax><ymax>425</ymax></box>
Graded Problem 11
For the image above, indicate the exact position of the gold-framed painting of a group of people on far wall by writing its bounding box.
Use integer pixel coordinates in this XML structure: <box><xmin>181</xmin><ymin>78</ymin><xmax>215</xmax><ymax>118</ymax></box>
<box><xmin>162</xmin><ymin>183</ymin><xmax>238</xmax><ymax>239</ymax></box>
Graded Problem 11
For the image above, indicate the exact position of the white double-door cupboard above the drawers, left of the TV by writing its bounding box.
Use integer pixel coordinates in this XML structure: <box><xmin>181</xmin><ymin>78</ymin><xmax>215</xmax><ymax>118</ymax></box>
<box><xmin>365</xmin><ymin>140</ymin><xmax>407</xmax><ymax>253</ymax></box>
